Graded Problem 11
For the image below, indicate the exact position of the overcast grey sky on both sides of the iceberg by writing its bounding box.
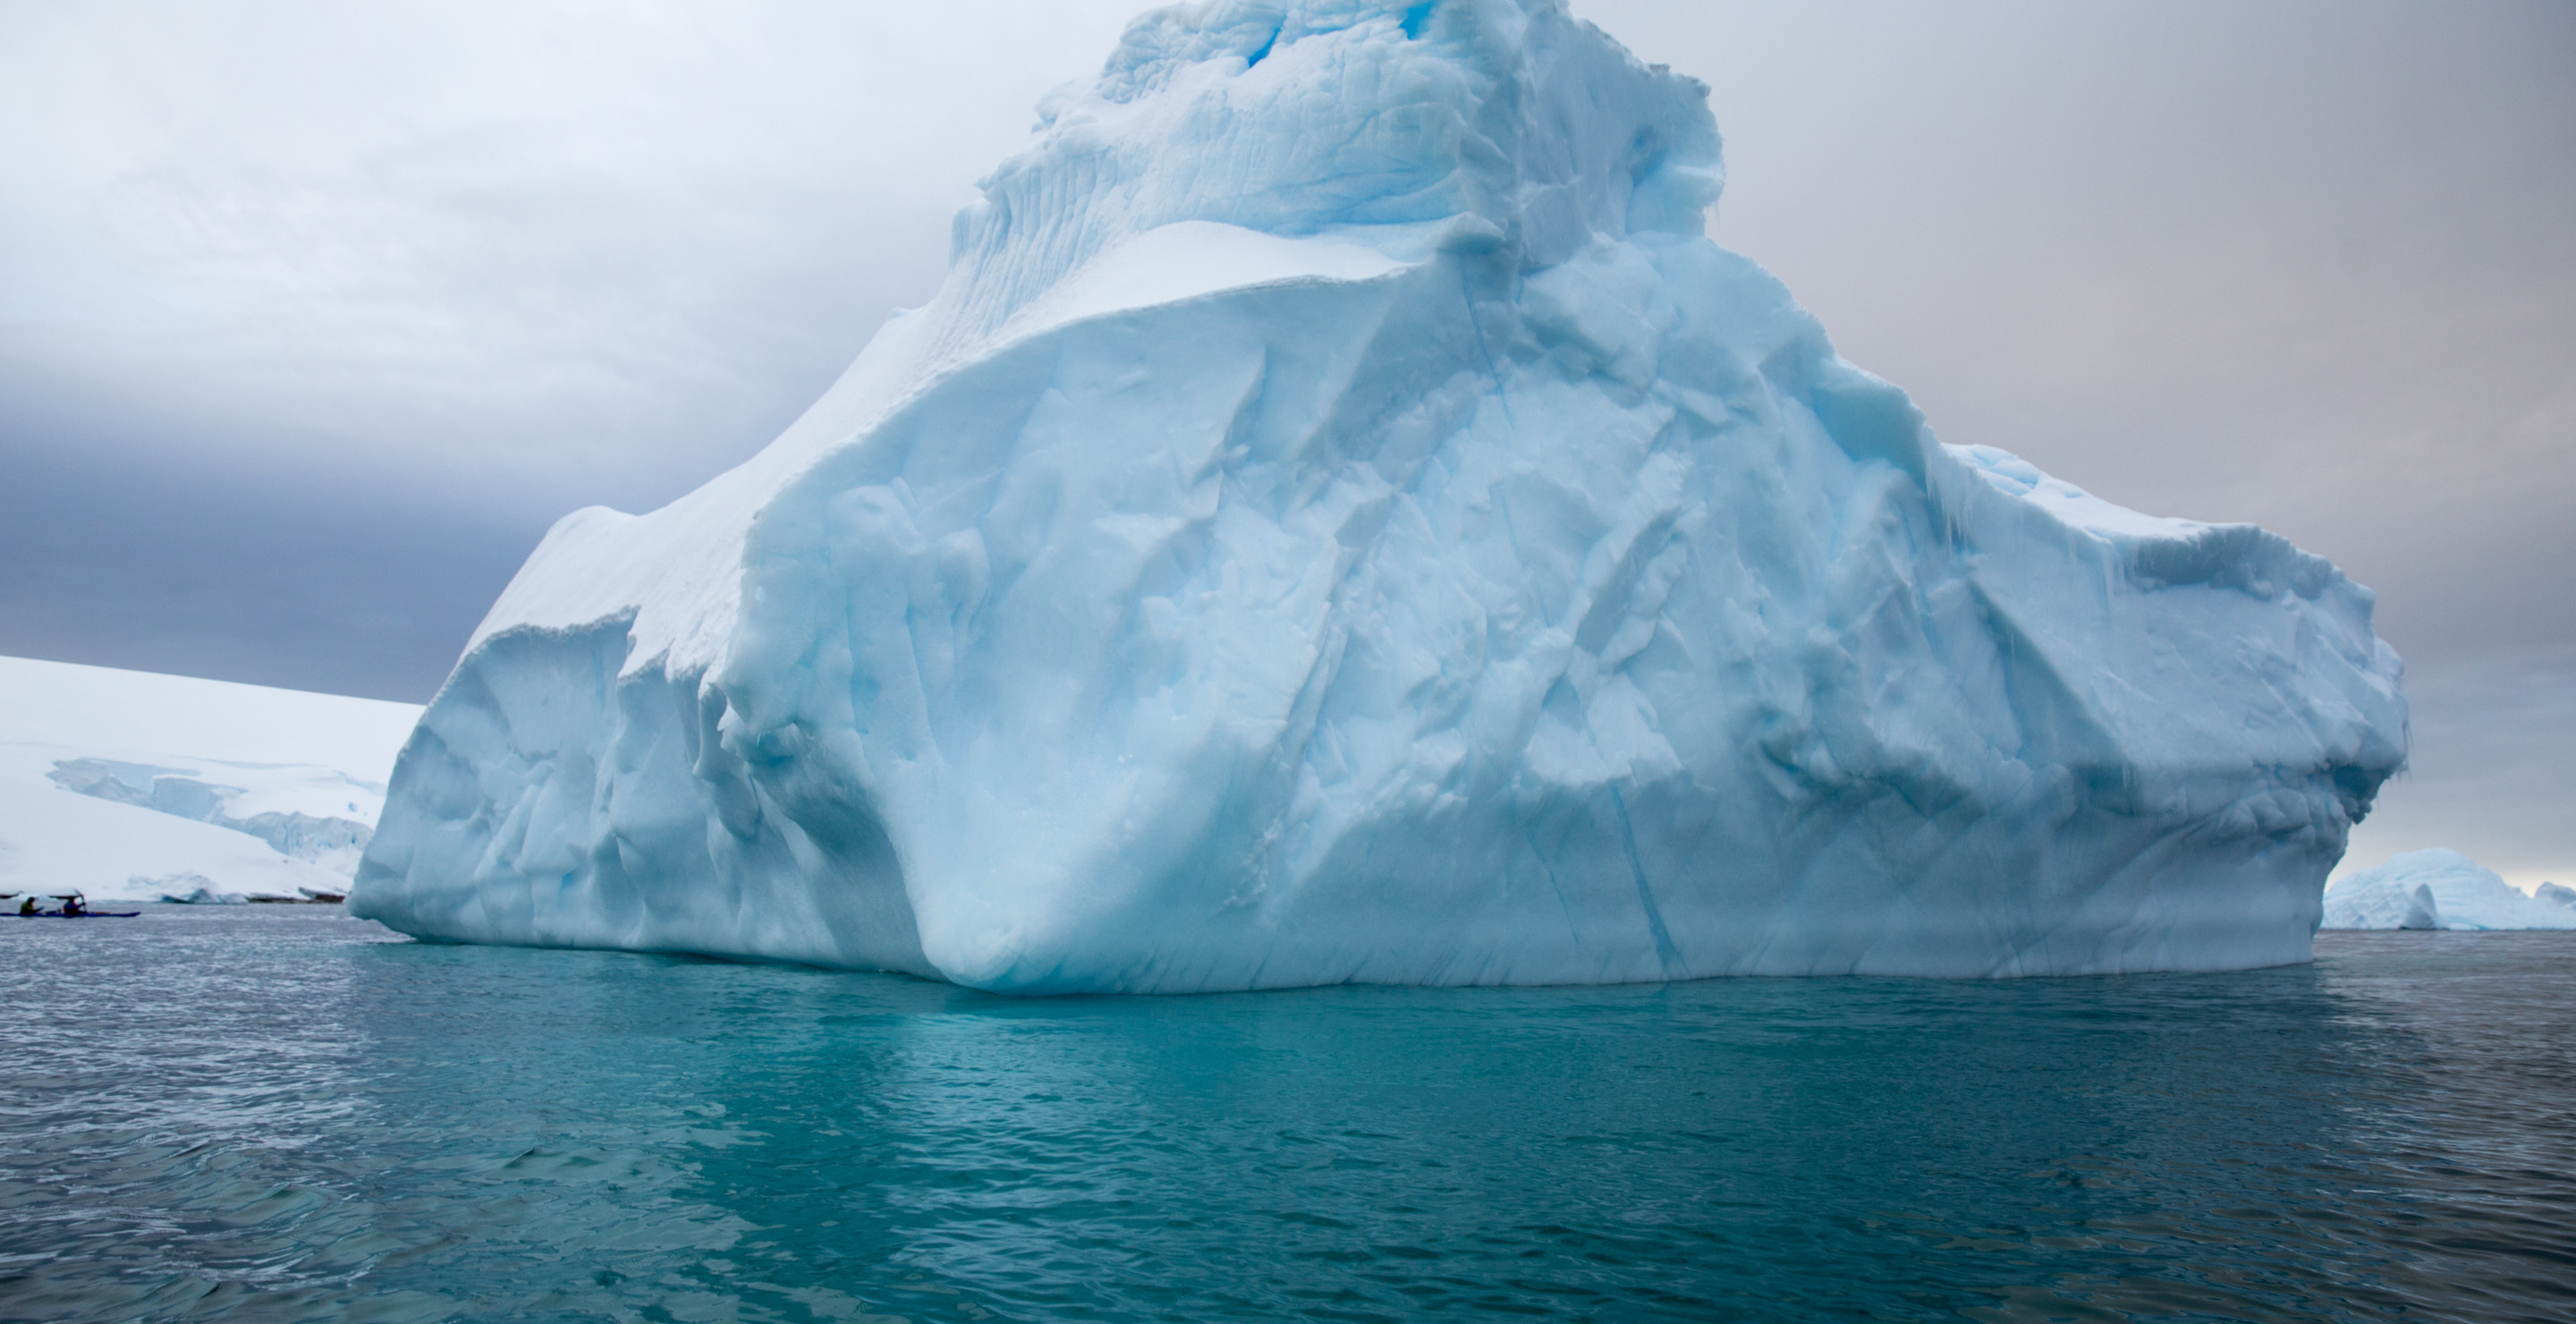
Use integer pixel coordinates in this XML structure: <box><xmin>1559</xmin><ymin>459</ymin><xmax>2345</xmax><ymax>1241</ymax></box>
<box><xmin>0</xmin><ymin>0</ymin><xmax>2576</xmax><ymax>884</ymax></box>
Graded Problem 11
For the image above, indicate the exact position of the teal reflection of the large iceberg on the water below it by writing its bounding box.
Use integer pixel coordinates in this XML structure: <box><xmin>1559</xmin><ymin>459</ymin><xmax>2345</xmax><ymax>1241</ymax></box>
<box><xmin>317</xmin><ymin>948</ymin><xmax>2421</xmax><ymax>1319</ymax></box>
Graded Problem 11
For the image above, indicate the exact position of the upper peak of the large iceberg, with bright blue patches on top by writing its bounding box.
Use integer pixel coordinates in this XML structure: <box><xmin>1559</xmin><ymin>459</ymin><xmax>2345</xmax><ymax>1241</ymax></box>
<box><xmin>940</xmin><ymin>0</ymin><xmax>1721</xmax><ymax>343</ymax></box>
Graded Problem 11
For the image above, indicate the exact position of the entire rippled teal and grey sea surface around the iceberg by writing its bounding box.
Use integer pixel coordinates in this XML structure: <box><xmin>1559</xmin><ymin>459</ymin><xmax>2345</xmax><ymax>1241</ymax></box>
<box><xmin>0</xmin><ymin>907</ymin><xmax>2576</xmax><ymax>1321</ymax></box>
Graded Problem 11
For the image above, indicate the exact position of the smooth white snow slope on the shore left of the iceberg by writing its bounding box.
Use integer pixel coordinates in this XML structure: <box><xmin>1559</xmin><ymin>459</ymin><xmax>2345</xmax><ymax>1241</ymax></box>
<box><xmin>0</xmin><ymin>657</ymin><xmax>419</xmax><ymax>899</ymax></box>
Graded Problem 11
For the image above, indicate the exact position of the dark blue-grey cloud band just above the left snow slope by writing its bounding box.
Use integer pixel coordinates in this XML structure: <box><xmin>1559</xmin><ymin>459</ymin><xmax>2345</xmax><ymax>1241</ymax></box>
<box><xmin>0</xmin><ymin>404</ymin><xmax>554</xmax><ymax>700</ymax></box>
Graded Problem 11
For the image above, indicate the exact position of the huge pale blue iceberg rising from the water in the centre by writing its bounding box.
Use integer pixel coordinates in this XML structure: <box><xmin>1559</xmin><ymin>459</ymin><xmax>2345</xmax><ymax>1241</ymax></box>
<box><xmin>351</xmin><ymin>0</ymin><xmax>2406</xmax><ymax>992</ymax></box>
